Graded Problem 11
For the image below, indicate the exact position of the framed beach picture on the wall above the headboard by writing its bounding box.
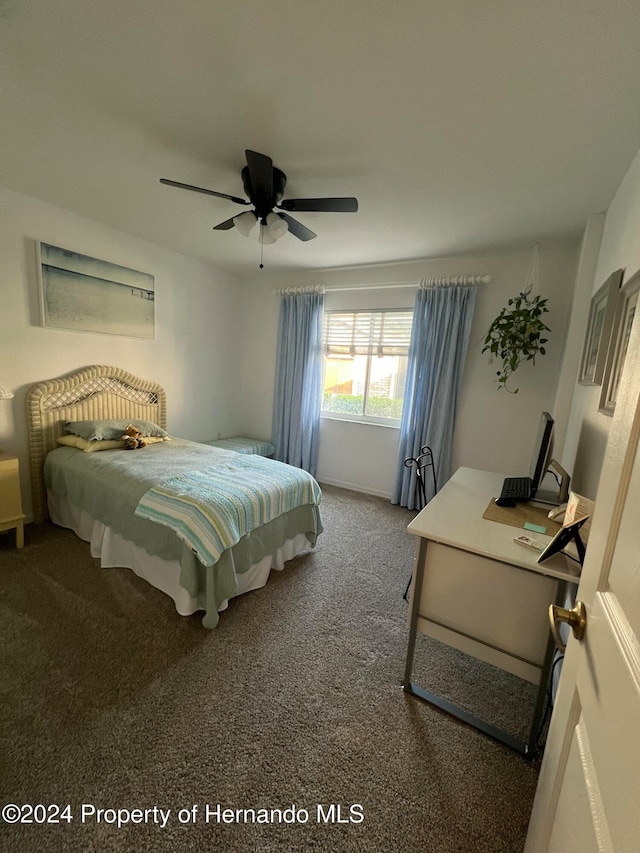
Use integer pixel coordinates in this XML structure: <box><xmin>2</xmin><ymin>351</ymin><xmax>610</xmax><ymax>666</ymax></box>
<box><xmin>36</xmin><ymin>242</ymin><xmax>155</xmax><ymax>340</ymax></box>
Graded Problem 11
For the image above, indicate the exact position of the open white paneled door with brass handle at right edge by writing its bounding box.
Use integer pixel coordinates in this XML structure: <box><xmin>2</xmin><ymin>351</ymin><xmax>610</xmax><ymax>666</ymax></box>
<box><xmin>525</xmin><ymin>302</ymin><xmax>640</xmax><ymax>853</ymax></box>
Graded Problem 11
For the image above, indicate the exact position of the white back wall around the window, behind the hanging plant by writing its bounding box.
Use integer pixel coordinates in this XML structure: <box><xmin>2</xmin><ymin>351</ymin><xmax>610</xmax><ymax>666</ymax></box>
<box><xmin>239</xmin><ymin>242</ymin><xmax>578</xmax><ymax>497</ymax></box>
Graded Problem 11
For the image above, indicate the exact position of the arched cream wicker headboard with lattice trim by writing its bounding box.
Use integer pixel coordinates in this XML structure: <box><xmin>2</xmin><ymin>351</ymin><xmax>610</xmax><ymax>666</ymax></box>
<box><xmin>27</xmin><ymin>365</ymin><xmax>167</xmax><ymax>521</ymax></box>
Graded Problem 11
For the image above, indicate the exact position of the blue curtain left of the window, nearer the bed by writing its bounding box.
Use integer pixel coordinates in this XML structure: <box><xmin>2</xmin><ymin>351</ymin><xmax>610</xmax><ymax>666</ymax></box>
<box><xmin>272</xmin><ymin>286</ymin><xmax>324</xmax><ymax>475</ymax></box>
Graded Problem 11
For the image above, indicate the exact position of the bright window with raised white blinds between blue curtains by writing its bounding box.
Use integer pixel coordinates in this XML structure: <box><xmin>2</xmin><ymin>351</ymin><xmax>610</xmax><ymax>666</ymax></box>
<box><xmin>322</xmin><ymin>311</ymin><xmax>413</xmax><ymax>425</ymax></box>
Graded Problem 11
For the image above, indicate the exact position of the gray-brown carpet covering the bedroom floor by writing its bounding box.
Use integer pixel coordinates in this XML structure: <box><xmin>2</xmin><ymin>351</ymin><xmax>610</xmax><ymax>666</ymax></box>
<box><xmin>0</xmin><ymin>487</ymin><xmax>538</xmax><ymax>853</ymax></box>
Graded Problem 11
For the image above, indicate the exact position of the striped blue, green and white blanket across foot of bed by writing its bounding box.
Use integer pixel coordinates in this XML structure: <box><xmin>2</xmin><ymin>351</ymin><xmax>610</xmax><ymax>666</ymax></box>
<box><xmin>136</xmin><ymin>454</ymin><xmax>321</xmax><ymax>566</ymax></box>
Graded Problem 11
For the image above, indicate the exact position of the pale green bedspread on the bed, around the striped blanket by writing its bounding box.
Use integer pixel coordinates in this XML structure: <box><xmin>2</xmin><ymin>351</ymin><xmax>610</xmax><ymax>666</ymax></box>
<box><xmin>44</xmin><ymin>439</ymin><xmax>322</xmax><ymax>628</ymax></box>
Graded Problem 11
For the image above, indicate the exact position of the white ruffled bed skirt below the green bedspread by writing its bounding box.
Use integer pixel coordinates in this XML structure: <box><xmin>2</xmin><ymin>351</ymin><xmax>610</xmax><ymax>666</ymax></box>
<box><xmin>47</xmin><ymin>491</ymin><xmax>312</xmax><ymax>616</ymax></box>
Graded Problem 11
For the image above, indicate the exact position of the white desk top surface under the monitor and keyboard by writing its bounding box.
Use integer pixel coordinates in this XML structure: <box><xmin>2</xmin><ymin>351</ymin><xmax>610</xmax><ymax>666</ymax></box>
<box><xmin>407</xmin><ymin>468</ymin><xmax>580</xmax><ymax>583</ymax></box>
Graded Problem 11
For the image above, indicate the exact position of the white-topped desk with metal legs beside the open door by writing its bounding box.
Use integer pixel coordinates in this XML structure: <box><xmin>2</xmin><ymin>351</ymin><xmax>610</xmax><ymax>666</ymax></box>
<box><xmin>404</xmin><ymin>468</ymin><xmax>580</xmax><ymax>758</ymax></box>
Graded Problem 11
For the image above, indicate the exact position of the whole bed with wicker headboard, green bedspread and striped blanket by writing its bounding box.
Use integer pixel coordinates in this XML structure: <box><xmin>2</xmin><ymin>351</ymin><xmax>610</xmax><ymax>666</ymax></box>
<box><xmin>27</xmin><ymin>365</ymin><xmax>322</xmax><ymax>628</ymax></box>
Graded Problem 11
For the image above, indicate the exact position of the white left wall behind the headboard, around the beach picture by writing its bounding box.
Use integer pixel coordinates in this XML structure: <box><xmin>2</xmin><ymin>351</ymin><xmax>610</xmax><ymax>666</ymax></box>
<box><xmin>0</xmin><ymin>188</ymin><xmax>240</xmax><ymax>517</ymax></box>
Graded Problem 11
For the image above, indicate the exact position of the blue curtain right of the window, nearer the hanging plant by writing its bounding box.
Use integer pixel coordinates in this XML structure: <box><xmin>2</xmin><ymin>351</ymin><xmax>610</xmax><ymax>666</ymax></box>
<box><xmin>391</xmin><ymin>286</ymin><xmax>476</xmax><ymax>509</ymax></box>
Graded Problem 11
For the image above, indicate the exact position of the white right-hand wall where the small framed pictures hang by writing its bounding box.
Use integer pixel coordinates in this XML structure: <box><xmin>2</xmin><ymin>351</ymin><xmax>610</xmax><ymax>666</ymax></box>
<box><xmin>564</xmin><ymin>152</ymin><xmax>640</xmax><ymax>498</ymax></box>
